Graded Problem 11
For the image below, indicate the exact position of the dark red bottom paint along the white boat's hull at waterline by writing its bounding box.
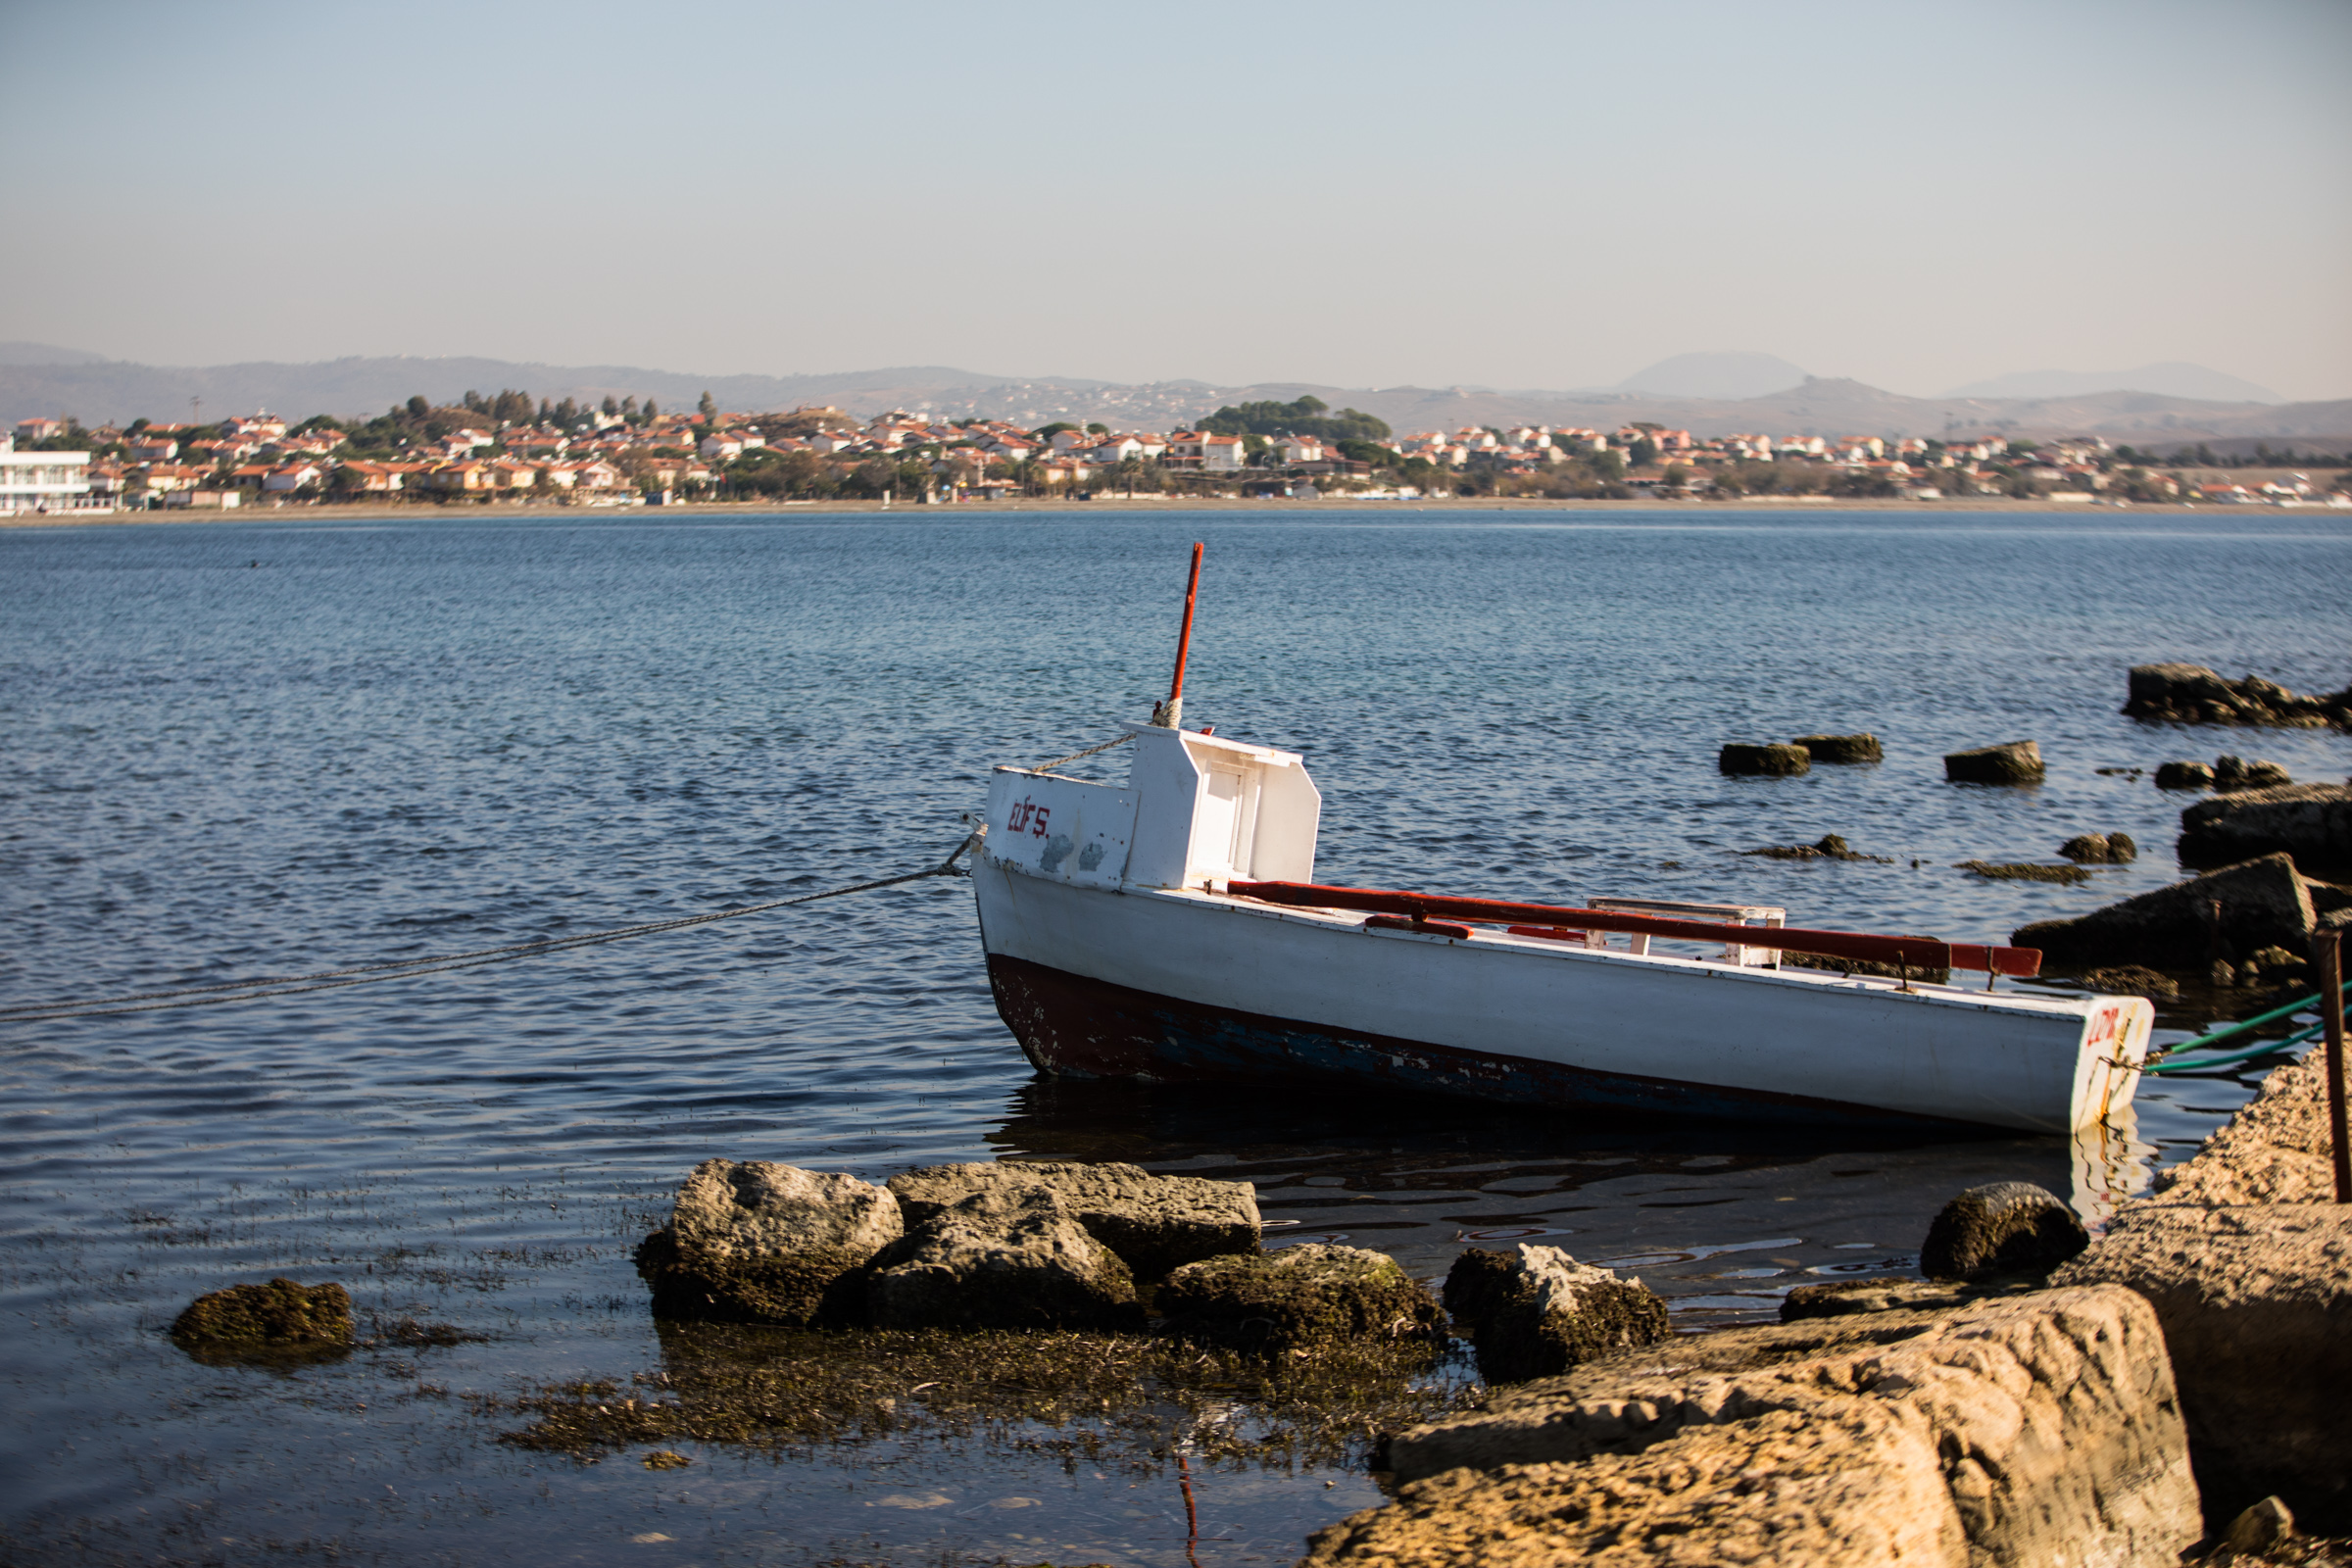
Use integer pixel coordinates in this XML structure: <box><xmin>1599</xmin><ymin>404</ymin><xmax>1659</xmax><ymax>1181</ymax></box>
<box><xmin>988</xmin><ymin>955</ymin><xmax>1969</xmax><ymax>1131</ymax></box>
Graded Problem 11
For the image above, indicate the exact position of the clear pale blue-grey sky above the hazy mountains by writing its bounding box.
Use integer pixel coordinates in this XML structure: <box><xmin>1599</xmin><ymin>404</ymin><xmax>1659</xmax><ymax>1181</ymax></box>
<box><xmin>0</xmin><ymin>0</ymin><xmax>2352</xmax><ymax>397</ymax></box>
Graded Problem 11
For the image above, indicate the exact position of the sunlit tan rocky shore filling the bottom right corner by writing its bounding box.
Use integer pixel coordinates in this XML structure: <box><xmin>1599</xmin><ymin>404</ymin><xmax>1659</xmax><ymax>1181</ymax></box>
<box><xmin>1305</xmin><ymin>1051</ymin><xmax>2352</xmax><ymax>1568</ymax></box>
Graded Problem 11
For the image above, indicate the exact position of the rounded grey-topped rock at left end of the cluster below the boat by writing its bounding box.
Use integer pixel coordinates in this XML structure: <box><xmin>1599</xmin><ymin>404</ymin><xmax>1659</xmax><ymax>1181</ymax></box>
<box><xmin>637</xmin><ymin>1159</ymin><xmax>904</xmax><ymax>1328</ymax></box>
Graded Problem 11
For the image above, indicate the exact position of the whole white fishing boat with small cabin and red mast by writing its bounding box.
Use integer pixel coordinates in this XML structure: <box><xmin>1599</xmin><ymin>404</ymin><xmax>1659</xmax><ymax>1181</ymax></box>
<box><xmin>974</xmin><ymin>548</ymin><xmax>2154</xmax><ymax>1133</ymax></box>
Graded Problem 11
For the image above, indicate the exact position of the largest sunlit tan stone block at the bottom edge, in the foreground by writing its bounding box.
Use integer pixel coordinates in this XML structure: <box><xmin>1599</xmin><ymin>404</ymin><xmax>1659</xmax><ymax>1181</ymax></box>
<box><xmin>1345</xmin><ymin>1289</ymin><xmax>2201</xmax><ymax>1568</ymax></box>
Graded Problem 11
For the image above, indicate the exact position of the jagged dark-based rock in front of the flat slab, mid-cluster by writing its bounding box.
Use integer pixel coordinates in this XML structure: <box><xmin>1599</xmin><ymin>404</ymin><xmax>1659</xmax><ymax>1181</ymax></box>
<box><xmin>865</xmin><ymin>1187</ymin><xmax>1143</xmax><ymax>1333</ymax></box>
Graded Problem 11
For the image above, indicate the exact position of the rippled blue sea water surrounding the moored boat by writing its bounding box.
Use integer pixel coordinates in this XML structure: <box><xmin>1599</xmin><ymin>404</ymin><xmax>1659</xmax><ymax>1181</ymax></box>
<box><xmin>0</xmin><ymin>511</ymin><xmax>2352</xmax><ymax>1568</ymax></box>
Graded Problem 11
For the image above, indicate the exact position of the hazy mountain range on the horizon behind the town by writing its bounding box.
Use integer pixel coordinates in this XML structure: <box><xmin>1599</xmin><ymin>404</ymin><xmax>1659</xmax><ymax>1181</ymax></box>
<box><xmin>0</xmin><ymin>343</ymin><xmax>2352</xmax><ymax>452</ymax></box>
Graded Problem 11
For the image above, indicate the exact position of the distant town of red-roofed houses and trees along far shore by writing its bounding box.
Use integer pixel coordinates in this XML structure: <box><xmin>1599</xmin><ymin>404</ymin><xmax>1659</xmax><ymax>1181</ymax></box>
<box><xmin>0</xmin><ymin>390</ymin><xmax>2352</xmax><ymax>513</ymax></box>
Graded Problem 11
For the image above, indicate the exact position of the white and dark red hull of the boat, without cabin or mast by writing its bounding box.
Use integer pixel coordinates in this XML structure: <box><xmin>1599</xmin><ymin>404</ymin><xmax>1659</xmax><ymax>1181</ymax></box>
<box><xmin>974</xmin><ymin>860</ymin><xmax>2152</xmax><ymax>1133</ymax></box>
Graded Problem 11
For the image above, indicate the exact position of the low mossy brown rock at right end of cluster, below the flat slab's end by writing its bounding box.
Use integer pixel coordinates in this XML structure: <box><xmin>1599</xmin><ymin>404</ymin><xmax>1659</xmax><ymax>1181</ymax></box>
<box><xmin>1154</xmin><ymin>1242</ymin><xmax>1445</xmax><ymax>1356</ymax></box>
